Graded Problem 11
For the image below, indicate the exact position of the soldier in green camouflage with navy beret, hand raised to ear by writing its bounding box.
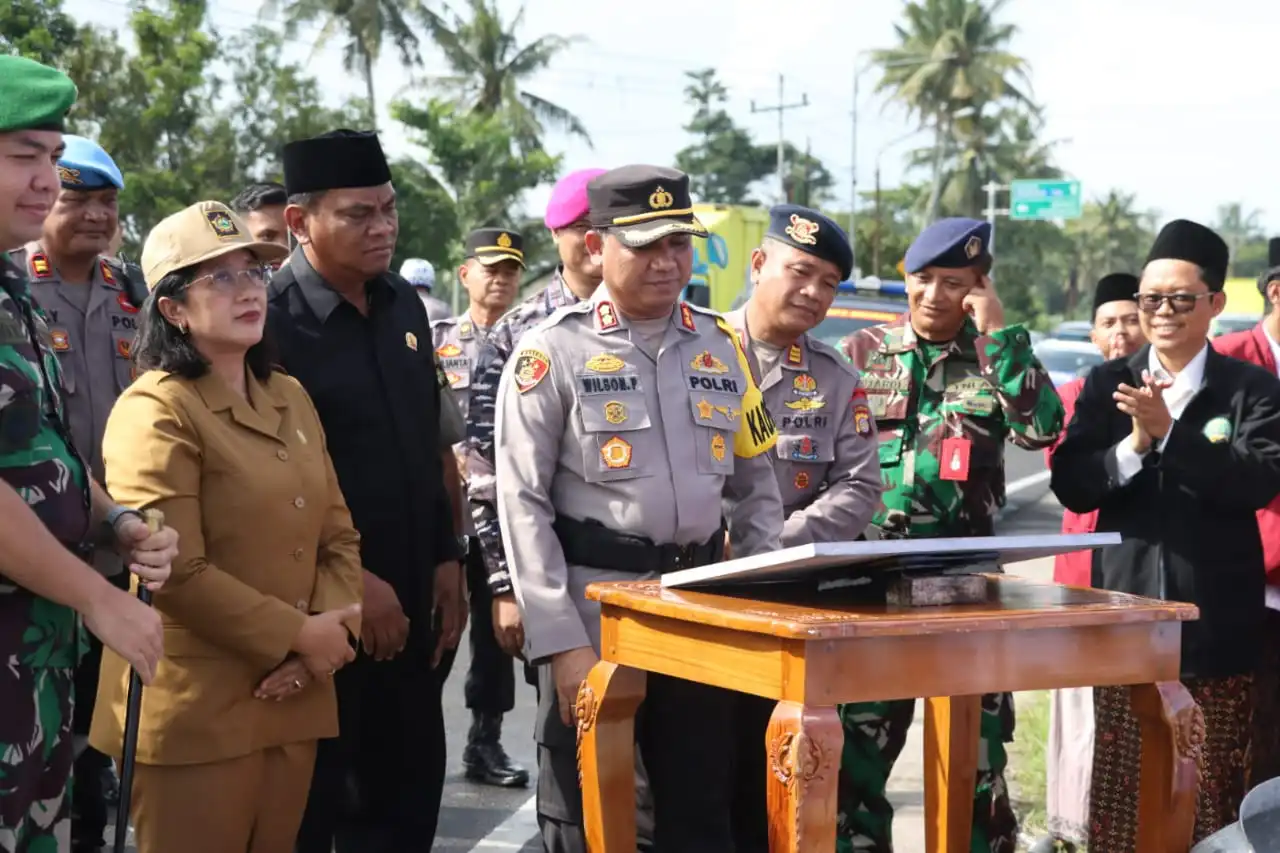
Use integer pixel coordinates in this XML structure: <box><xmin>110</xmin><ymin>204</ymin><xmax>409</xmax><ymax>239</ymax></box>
<box><xmin>840</xmin><ymin>213</ymin><xmax>1062</xmax><ymax>853</ymax></box>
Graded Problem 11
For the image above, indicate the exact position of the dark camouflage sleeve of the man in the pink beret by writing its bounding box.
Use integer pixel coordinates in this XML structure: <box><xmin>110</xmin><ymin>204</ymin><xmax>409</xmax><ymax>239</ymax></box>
<box><xmin>467</xmin><ymin>324</ymin><xmax>512</xmax><ymax>596</ymax></box>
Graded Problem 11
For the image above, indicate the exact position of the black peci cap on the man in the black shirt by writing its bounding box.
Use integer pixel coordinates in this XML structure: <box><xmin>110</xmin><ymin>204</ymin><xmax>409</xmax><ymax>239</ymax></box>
<box><xmin>280</xmin><ymin>129</ymin><xmax>392</xmax><ymax>196</ymax></box>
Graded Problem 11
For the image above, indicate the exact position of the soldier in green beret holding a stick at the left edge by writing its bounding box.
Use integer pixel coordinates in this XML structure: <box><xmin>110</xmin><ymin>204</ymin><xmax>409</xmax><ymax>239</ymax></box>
<box><xmin>0</xmin><ymin>56</ymin><xmax>177</xmax><ymax>853</ymax></box>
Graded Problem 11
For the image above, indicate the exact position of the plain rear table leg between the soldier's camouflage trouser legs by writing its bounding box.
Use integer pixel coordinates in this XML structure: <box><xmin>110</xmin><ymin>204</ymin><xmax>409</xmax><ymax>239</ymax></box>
<box><xmin>924</xmin><ymin>695</ymin><xmax>982</xmax><ymax>853</ymax></box>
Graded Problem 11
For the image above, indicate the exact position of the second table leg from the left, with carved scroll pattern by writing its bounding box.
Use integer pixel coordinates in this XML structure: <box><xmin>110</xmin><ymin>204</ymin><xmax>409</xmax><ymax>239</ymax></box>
<box><xmin>764</xmin><ymin>702</ymin><xmax>845</xmax><ymax>853</ymax></box>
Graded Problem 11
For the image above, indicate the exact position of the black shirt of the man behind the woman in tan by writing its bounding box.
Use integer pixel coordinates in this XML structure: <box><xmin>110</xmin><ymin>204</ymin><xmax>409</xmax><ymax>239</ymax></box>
<box><xmin>268</xmin><ymin>250</ymin><xmax>460</xmax><ymax>614</ymax></box>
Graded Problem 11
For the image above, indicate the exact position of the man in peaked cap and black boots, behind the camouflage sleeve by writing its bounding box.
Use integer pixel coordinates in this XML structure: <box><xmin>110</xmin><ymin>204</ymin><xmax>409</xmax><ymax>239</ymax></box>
<box><xmin>431</xmin><ymin>228</ymin><xmax>529</xmax><ymax>788</ymax></box>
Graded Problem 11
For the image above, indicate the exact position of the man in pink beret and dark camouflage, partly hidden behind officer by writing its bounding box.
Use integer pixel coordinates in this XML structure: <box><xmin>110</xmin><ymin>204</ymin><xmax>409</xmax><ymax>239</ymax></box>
<box><xmin>467</xmin><ymin>169</ymin><xmax>604</xmax><ymax>654</ymax></box>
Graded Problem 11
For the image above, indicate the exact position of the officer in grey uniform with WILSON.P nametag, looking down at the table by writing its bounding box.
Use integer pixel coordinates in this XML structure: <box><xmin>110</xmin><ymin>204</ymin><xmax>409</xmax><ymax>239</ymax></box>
<box><xmin>495</xmin><ymin>165</ymin><xmax>782</xmax><ymax>853</ymax></box>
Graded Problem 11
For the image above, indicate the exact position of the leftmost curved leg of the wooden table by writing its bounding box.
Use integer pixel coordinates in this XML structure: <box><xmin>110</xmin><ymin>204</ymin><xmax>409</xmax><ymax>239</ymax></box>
<box><xmin>575</xmin><ymin>661</ymin><xmax>645</xmax><ymax>853</ymax></box>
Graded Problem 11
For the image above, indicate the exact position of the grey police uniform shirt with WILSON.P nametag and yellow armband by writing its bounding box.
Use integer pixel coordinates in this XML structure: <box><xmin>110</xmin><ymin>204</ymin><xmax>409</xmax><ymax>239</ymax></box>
<box><xmin>495</xmin><ymin>284</ymin><xmax>782</xmax><ymax>661</ymax></box>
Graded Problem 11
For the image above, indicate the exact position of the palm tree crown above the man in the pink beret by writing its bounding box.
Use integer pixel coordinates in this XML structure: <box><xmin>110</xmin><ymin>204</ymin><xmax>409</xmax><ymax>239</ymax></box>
<box><xmin>419</xmin><ymin>0</ymin><xmax>591</xmax><ymax>147</ymax></box>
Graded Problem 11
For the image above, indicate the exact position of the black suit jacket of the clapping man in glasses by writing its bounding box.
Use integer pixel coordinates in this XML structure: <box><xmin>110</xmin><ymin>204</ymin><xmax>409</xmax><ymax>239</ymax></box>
<box><xmin>1052</xmin><ymin>346</ymin><xmax>1280</xmax><ymax>678</ymax></box>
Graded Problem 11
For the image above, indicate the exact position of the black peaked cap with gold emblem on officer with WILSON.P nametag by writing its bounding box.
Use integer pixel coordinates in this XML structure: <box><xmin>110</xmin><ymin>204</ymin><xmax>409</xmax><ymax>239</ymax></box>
<box><xmin>586</xmin><ymin>165</ymin><xmax>707</xmax><ymax>248</ymax></box>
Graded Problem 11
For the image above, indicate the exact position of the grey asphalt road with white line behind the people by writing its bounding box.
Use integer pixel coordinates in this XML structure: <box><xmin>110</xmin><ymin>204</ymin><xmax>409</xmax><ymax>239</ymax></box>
<box><xmin>108</xmin><ymin>447</ymin><xmax>1062</xmax><ymax>853</ymax></box>
